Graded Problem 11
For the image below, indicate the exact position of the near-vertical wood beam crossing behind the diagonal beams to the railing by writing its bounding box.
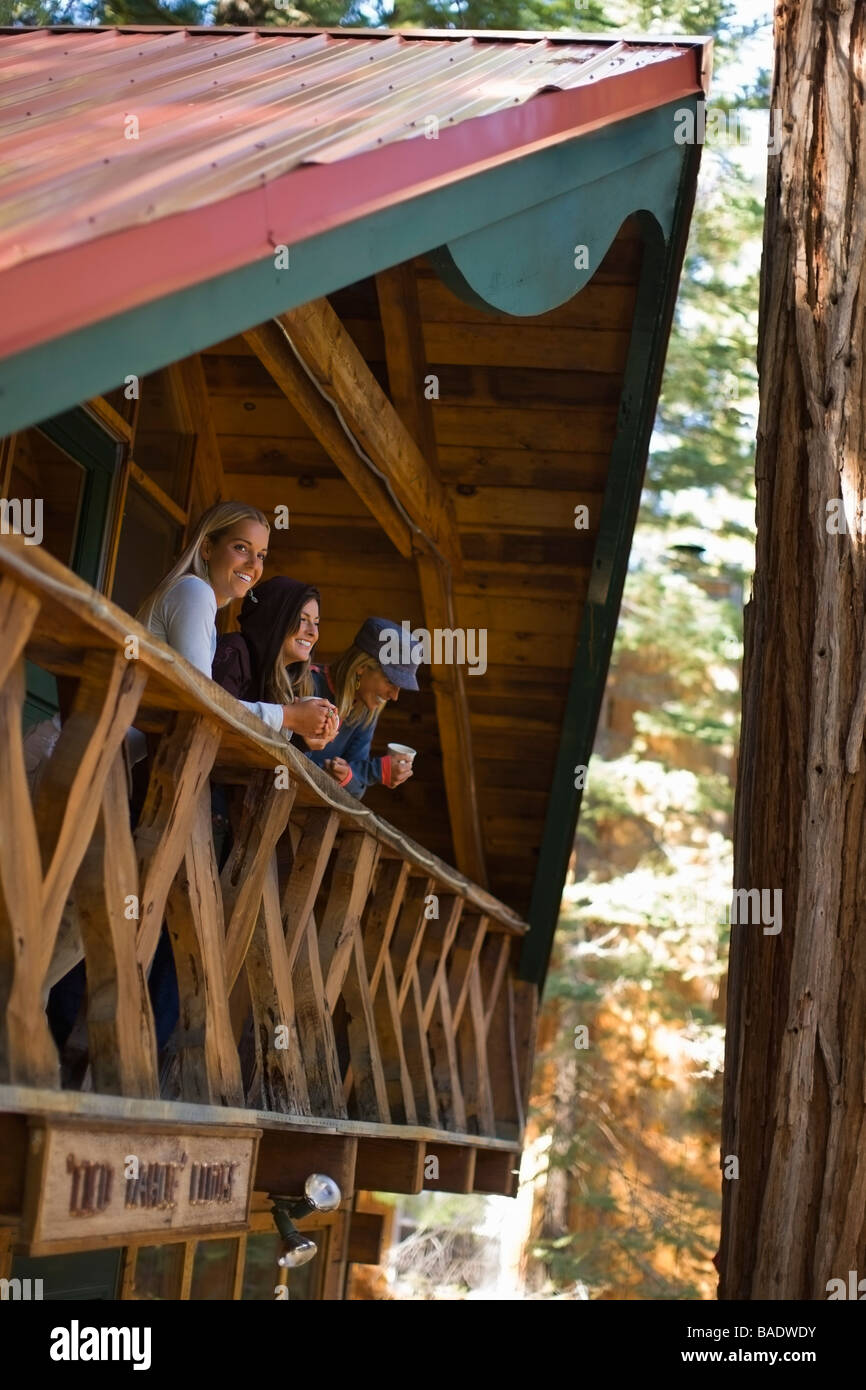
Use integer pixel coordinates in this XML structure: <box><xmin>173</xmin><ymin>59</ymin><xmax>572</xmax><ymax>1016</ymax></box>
<box><xmin>377</xmin><ymin>264</ymin><xmax>487</xmax><ymax>887</ymax></box>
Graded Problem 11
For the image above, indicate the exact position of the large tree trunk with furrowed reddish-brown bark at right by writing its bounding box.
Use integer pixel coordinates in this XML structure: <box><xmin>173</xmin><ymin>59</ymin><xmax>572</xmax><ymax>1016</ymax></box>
<box><xmin>719</xmin><ymin>0</ymin><xmax>866</xmax><ymax>1298</ymax></box>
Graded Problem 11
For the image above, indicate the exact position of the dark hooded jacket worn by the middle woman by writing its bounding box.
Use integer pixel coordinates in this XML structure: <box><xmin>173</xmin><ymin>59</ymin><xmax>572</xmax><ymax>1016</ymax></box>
<box><xmin>211</xmin><ymin>574</ymin><xmax>318</xmax><ymax>701</ymax></box>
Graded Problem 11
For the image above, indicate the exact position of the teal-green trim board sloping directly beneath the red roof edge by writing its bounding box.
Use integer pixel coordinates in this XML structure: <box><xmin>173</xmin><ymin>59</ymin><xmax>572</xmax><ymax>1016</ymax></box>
<box><xmin>0</xmin><ymin>97</ymin><xmax>696</xmax><ymax>435</ymax></box>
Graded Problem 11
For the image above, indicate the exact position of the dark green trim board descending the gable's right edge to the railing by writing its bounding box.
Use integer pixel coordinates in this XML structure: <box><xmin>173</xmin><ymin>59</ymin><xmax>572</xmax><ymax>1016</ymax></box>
<box><xmin>520</xmin><ymin>146</ymin><xmax>701</xmax><ymax>987</ymax></box>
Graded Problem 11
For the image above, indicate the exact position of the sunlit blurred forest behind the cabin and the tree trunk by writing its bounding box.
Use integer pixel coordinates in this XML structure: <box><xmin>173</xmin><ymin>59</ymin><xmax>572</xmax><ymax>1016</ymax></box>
<box><xmin>0</xmin><ymin>0</ymin><xmax>771</xmax><ymax>1300</ymax></box>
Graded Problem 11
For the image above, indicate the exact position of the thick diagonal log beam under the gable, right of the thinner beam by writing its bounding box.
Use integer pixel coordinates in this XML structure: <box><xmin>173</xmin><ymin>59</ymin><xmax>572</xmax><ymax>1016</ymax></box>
<box><xmin>279</xmin><ymin>299</ymin><xmax>463</xmax><ymax>574</ymax></box>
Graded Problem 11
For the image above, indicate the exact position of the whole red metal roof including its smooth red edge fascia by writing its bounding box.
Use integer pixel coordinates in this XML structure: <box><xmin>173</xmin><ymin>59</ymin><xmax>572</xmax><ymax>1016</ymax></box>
<box><xmin>0</xmin><ymin>28</ymin><xmax>705</xmax><ymax>356</ymax></box>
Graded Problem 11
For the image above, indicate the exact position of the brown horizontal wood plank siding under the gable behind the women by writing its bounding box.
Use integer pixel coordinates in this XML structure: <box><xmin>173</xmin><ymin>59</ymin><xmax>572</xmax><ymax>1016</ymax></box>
<box><xmin>202</xmin><ymin>224</ymin><xmax>642</xmax><ymax>912</ymax></box>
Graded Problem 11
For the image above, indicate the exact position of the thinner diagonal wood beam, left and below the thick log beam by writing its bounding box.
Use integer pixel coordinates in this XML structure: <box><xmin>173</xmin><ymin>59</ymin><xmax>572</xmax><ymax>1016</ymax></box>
<box><xmin>243</xmin><ymin>322</ymin><xmax>411</xmax><ymax>557</ymax></box>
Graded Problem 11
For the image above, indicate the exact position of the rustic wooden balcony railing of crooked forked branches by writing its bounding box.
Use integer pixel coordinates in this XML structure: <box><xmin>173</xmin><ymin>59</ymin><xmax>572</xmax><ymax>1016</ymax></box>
<box><xmin>0</xmin><ymin>537</ymin><xmax>535</xmax><ymax>1147</ymax></box>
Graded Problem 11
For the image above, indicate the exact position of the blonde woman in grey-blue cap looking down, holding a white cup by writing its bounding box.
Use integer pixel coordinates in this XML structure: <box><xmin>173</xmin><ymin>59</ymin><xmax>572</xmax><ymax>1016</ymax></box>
<box><xmin>307</xmin><ymin>617</ymin><xmax>421</xmax><ymax>799</ymax></box>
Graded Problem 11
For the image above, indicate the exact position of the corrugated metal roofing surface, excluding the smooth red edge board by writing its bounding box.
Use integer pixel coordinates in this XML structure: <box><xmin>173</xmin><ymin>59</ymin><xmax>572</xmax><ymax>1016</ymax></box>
<box><xmin>0</xmin><ymin>28</ymin><xmax>699</xmax><ymax>268</ymax></box>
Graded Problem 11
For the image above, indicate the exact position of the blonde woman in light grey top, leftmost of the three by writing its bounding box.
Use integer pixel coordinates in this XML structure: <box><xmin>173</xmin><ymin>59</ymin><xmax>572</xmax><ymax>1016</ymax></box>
<box><xmin>138</xmin><ymin>502</ymin><xmax>336</xmax><ymax>741</ymax></box>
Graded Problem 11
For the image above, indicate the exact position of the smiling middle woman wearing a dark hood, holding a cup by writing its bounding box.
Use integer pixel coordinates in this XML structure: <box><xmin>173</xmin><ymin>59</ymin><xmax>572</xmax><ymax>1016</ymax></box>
<box><xmin>213</xmin><ymin>574</ymin><xmax>339</xmax><ymax>748</ymax></box>
